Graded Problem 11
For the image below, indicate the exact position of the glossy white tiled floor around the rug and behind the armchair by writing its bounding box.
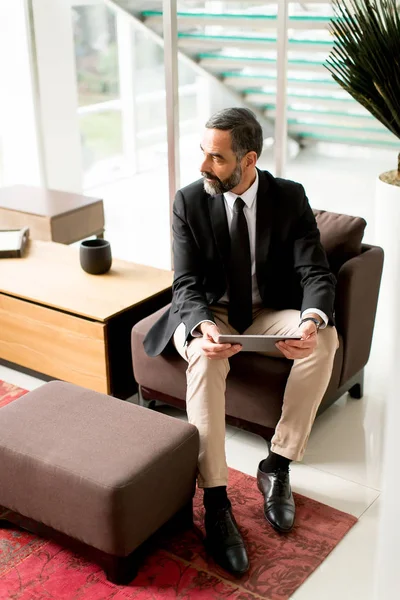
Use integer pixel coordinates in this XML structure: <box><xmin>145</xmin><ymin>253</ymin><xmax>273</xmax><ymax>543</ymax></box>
<box><xmin>0</xmin><ymin>142</ymin><xmax>395</xmax><ymax>600</ymax></box>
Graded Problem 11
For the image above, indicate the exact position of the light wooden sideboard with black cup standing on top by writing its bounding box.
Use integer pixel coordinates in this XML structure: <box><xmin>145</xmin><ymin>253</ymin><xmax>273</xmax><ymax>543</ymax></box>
<box><xmin>0</xmin><ymin>241</ymin><xmax>172</xmax><ymax>398</ymax></box>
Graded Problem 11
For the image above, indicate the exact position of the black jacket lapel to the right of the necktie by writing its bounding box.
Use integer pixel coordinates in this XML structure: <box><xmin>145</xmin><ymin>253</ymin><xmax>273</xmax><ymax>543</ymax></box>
<box><xmin>256</xmin><ymin>169</ymin><xmax>273</xmax><ymax>290</ymax></box>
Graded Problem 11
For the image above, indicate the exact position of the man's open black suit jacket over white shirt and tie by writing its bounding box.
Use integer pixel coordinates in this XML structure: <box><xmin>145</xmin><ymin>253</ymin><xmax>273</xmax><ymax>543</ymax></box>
<box><xmin>144</xmin><ymin>171</ymin><xmax>336</xmax><ymax>356</ymax></box>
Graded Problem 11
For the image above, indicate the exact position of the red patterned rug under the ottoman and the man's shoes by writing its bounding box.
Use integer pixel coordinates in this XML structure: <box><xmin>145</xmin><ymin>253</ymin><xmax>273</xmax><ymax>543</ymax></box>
<box><xmin>0</xmin><ymin>381</ymin><xmax>357</xmax><ymax>600</ymax></box>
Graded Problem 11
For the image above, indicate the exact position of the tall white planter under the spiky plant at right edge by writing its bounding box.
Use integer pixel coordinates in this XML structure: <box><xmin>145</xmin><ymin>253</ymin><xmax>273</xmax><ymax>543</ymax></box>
<box><xmin>374</xmin><ymin>172</ymin><xmax>400</xmax><ymax>600</ymax></box>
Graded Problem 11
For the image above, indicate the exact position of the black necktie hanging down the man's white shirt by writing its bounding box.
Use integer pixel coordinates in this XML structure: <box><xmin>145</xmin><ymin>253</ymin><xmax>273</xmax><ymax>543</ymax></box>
<box><xmin>228</xmin><ymin>198</ymin><xmax>253</xmax><ymax>333</ymax></box>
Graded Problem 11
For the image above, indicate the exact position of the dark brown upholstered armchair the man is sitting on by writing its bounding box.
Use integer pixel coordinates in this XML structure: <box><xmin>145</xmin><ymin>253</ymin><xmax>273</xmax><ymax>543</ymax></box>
<box><xmin>132</xmin><ymin>210</ymin><xmax>383</xmax><ymax>439</ymax></box>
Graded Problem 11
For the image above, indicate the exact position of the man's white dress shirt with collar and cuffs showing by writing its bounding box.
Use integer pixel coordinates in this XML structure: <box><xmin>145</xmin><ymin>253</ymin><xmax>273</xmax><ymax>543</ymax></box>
<box><xmin>191</xmin><ymin>170</ymin><xmax>329</xmax><ymax>337</ymax></box>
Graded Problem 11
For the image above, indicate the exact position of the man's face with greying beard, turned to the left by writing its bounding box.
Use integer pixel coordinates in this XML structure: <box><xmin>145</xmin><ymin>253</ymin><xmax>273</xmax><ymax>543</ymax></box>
<box><xmin>200</xmin><ymin>129</ymin><xmax>242</xmax><ymax>196</ymax></box>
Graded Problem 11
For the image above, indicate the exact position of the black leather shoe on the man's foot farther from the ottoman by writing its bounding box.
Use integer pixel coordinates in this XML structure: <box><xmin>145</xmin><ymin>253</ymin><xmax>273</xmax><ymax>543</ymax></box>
<box><xmin>257</xmin><ymin>461</ymin><xmax>296</xmax><ymax>533</ymax></box>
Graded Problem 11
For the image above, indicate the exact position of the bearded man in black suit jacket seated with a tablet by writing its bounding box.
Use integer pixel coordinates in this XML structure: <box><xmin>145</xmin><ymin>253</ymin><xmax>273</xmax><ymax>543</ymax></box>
<box><xmin>144</xmin><ymin>108</ymin><xmax>337</xmax><ymax>576</ymax></box>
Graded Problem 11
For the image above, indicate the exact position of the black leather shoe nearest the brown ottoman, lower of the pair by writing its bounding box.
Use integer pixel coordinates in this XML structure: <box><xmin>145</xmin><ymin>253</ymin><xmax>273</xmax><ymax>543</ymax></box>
<box><xmin>204</xmin><ymin>504</ymin><xmax>249</xmax><ymax>577</ymax></box>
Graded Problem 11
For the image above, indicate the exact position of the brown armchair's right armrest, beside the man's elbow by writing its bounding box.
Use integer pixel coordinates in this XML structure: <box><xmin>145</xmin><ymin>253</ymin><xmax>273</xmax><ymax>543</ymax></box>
<box><xmin>336</xmin><ymin>244</ymin><xmax>383</xmax><ymax>385</ymax></box>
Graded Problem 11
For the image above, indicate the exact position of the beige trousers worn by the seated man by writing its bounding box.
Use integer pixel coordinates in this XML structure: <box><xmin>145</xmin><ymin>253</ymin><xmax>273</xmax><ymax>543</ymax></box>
<box><xmin>173</xmin><ymin>305</ymin><xmax>338</xmax><ymax>487</ymax></box>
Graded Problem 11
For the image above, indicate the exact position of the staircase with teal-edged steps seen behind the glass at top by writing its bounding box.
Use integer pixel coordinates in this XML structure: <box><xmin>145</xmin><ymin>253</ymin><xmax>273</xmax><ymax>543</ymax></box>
<box><xmin>108</xmin><ymin>0</ymin><xmax>398</xmax><ymax>147</ymax></box>
